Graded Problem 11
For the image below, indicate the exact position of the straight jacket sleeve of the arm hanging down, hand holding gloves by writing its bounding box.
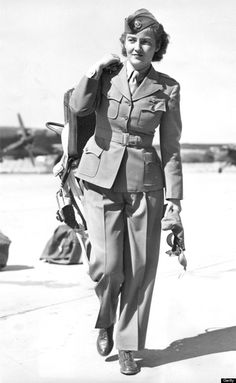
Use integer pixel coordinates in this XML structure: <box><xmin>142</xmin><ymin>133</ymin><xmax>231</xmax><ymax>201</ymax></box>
<box><xmin>160</xmin><ymin>83</ymin><xmax>183</xmax><ymax>199</ymax></box>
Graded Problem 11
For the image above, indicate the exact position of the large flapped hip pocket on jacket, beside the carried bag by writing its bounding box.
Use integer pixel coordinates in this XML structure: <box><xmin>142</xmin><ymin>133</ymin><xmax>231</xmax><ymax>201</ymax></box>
<box><xmin>78</xmin><ymin>137</ymin><xmax>103</xmax><ymax>177</ymax></box>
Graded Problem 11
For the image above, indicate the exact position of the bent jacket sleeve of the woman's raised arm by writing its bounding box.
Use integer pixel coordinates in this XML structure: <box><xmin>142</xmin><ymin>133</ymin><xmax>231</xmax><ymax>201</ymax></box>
<box><xmin>69</xmin><ymin>76</ymin><xmax>100</xmax><ymax>116</ymax></box>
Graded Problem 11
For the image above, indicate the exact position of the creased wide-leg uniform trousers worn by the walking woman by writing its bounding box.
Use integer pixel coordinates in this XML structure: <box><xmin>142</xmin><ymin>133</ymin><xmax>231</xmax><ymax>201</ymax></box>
<box><xmin>84</xmin><ymin>182</ymin><xmax>164</xmax><ymax>351</ymax></box>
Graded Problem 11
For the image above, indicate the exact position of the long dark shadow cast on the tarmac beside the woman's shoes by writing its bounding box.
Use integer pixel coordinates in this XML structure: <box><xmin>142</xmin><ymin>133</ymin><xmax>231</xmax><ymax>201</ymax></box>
<box><xmin>106</xmin><ymin>326</ymin><xmax>236</xmax><ymax>367</ymax></box>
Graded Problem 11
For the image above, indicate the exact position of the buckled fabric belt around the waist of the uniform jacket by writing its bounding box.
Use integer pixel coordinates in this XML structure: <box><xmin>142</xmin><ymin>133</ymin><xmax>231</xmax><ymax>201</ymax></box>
<box><xmin>96</xmin><ymin>132</ymin><xmax>153</xmax><ymax>147</ymax></box>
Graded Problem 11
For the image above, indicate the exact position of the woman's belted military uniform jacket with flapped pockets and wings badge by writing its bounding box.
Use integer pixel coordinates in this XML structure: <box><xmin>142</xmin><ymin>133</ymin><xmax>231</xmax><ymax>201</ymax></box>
<box><xmin>70</xmin><ymin>64</ymin><xmax>182</xmax><ymax>199</ymax></box>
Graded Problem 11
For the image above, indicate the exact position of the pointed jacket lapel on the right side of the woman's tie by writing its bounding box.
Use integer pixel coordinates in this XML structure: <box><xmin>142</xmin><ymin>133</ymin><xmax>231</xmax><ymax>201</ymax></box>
<box><xmin>133</xmin><ymin>66</ymin><xmax>163</xmax><ymax>101</ymax></box>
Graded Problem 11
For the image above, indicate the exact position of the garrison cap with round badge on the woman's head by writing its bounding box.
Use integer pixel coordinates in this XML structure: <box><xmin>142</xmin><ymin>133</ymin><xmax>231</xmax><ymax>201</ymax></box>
<box><xmin>125</xmin><ymin>8</ymin><xmax>159</xmax><ymax>33</ymax></box>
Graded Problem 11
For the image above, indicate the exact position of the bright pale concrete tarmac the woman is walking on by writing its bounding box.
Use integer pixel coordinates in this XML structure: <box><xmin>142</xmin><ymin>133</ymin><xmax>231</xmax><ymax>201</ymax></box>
<box><xmin>0</xmin><ymin>164</ymin><xmax>236</xmax><ymax>383</ymax></box>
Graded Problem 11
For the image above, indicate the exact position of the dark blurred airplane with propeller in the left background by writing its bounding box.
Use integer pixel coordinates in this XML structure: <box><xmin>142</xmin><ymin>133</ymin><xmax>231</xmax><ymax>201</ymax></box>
<box><xmin>0</xmin><ymin>113</ymin><xmax>63</xmax><ymax>165</ymax></box>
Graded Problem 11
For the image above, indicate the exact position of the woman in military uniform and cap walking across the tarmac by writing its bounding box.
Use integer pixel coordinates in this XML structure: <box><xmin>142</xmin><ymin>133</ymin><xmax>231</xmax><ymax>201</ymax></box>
<box><xmin>70</xmin><ymin>9</ymin><xmax>182</xmax><ymax>375</ymax></box>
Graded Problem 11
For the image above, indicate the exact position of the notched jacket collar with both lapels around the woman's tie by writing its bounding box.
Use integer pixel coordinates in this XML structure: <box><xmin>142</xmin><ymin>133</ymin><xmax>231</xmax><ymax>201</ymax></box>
<box><xmin>111</xmin><ymin>63</ymin><xmax>163</xmax><ymax>101</ymax></box>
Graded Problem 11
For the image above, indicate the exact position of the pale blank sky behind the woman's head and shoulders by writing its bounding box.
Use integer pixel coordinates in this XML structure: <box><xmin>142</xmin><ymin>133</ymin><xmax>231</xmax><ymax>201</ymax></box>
<box><xmin>0</xmin><ymin>0</ymin><xmax>236</xmax><ymax>143</ymax></box>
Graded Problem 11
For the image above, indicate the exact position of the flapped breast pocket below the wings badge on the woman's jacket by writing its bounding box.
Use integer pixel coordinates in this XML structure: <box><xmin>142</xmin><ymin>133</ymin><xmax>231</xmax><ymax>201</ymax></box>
<box><xmin>138</xmin><ymin>99</ymin><xmax>166</xmax><ymax>128</ymax></box>
